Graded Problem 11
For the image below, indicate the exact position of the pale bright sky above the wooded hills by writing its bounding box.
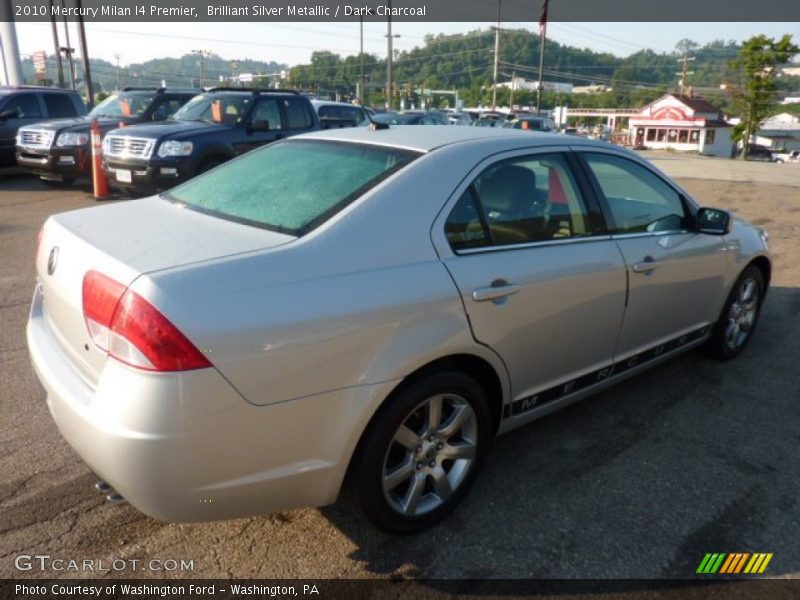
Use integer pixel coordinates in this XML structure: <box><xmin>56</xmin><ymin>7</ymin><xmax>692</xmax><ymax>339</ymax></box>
<box><xmin>17</xmin><ymin>22</ymin><xmax>800</xmax><ymax>66</ymax></box>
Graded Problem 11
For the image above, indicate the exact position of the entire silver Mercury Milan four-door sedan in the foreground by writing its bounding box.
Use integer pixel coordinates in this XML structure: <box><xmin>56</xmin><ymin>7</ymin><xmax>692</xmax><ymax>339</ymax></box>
<box><xmin>27</xmin><ymin>127</ymin><xmax>770</xmax><ymax>532</ymax></box>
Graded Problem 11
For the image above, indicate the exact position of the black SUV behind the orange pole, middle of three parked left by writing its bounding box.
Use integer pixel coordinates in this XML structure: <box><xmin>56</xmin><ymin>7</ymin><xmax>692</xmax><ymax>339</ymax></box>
<box><xmin>17</xmin><ymin>88</ymin><xmax>198</xmax><ymax>184</ymax></box>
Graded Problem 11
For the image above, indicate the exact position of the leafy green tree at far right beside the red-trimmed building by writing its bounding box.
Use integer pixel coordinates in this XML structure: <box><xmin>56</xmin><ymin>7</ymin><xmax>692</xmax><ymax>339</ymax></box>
<box><xmin>728</xmin><ymin>34</ymin><xmax>800</xmax><ymax>160</ymax></box>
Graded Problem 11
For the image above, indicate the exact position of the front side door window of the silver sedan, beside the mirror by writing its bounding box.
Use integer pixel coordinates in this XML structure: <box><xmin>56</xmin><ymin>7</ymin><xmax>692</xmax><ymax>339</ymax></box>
<box><xmin>583</xmin><ymin>153</ymin><xmax>687</xmax><ymax>233</ymax></box>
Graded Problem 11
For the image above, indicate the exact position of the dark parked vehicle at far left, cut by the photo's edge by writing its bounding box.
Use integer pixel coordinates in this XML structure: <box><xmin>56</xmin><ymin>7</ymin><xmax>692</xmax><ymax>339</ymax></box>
<box><xmin>0</xmin><ymin>86</ymin><xmax>86</xmax><ymax>167</ymax></box>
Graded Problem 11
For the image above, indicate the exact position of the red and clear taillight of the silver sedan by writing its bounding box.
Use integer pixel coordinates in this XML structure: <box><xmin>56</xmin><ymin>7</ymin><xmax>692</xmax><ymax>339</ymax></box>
<box><xmin>83</xmin><ymin>271</ymin><xmax>211</xmax><ymax>371</ymax></box>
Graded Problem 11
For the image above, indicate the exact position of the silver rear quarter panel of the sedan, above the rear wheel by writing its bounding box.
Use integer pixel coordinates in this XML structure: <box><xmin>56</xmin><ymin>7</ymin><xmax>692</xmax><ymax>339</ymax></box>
<box><xmin>133</xmin><ymin>141</ymin><xmax>507</xmax><ymax>405</ymax></box>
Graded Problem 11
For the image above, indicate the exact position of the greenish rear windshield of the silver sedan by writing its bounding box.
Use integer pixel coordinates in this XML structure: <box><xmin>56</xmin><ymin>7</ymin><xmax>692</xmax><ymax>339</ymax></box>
<box><xmin>164</xmin><ymin>140</ymin><xmax>419</xmax><ymax>236</ymax></box>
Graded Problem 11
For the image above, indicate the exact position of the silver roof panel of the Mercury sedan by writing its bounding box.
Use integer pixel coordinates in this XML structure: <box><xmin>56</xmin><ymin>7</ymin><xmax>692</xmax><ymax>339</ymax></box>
<box><xmin>300</xmin><ymin>125</ymin><xmax>608</xmax><ymax>152</ymax></box>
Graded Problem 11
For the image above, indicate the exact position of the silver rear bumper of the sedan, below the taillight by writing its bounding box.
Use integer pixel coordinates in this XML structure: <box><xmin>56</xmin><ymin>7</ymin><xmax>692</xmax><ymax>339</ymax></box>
<box><xmin>27</xmin><ymin>287</ymin><xmax>394</xmax><ymax>521</ymax></box>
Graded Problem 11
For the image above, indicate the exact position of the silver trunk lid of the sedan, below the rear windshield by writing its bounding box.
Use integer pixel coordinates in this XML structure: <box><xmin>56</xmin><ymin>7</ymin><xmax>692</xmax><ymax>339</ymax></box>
<box><xmin>36</xmin><ymin>197</ymin><xmax>295</xmax><ymax>385</ymax></box>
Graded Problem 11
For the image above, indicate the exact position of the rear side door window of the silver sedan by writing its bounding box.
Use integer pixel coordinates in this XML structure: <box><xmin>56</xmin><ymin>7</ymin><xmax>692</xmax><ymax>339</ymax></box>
<box><xmin>445</xmin><ymin>154</ymin><xmax>592</xmax><ymax>250</ymax></box>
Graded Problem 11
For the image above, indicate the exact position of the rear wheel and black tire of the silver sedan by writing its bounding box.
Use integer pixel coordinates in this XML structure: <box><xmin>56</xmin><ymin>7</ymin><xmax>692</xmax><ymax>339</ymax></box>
<box><xmin>347</xmin><ymin>371</ymin><xmax>492</xmax><ymax>534</ymax></box>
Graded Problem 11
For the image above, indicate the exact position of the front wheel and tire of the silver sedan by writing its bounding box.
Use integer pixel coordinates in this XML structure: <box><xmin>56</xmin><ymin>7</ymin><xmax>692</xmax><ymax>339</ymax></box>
<box><xmin>705</xmin><ymin>265</ymin><xmax>765</xmax><ymax>360</ymax></box>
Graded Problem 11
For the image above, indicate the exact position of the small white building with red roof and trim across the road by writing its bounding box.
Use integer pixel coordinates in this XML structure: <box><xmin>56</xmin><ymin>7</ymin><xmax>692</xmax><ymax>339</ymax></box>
<box><xmin>628</xmin><ymin>94</ymin><xmax>733</xmax><ymax>157</ymax></box>
